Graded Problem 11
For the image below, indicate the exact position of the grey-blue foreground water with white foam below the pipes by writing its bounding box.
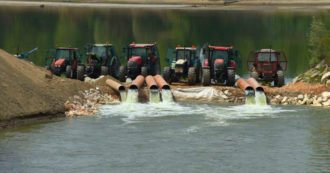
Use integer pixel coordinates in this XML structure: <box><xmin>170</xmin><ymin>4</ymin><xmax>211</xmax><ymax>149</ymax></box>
<box><xmin>0</xmin><ymin>103</ymin><xmax>330</xmax><ymax>173</ymax></box>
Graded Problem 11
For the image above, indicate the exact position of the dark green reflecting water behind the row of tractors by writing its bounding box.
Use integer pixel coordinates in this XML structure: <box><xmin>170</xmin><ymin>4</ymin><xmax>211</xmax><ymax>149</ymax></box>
<box><xmin>0</xmin><ymin>7</ymin><xmax>330</xmax><ymax>77</ymax></box>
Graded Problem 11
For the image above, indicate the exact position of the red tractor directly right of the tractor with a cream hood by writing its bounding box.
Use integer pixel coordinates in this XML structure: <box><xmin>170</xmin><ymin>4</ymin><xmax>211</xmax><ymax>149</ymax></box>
<box><xmin>201</xmin><ymin>45</ymin><xmax>240</xmax><ymax>86</ymax></box>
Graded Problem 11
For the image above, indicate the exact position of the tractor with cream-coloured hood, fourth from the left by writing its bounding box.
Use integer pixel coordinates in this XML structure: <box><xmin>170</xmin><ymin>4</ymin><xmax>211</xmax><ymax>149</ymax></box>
<box><xmin>163</xmin><ymin>45</ymin><xmax>202</xmax><ymax>85</ymax></box>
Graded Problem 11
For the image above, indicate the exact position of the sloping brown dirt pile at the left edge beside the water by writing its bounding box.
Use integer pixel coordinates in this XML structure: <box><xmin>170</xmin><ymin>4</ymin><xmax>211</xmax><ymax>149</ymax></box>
<box><xmin>0</xmin><ymin>49</ymin><xmax>93</xmax><ymax>120</ymax></box>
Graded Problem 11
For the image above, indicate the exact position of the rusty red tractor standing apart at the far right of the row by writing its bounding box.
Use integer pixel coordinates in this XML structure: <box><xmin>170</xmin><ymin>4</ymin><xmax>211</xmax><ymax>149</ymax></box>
<box><xmin>247</xmin><ymin>49</ymin><xmax>288</xmax><ymax>87</ymax></box>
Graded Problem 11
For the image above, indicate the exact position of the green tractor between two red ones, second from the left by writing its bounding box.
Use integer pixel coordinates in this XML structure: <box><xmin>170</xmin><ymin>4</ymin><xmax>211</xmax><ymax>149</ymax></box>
<box><xmin>84</xmin><ymin>43</ymin><xmax>121</xmax><ymax>78</ymax></box>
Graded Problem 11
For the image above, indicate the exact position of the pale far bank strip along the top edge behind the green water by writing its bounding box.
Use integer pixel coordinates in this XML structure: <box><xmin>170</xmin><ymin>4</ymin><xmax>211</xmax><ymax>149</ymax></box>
<box><xmin>0</xmin><ymin>0</ymin><xmax>330</xmax><ymax>10</ymax></box>
